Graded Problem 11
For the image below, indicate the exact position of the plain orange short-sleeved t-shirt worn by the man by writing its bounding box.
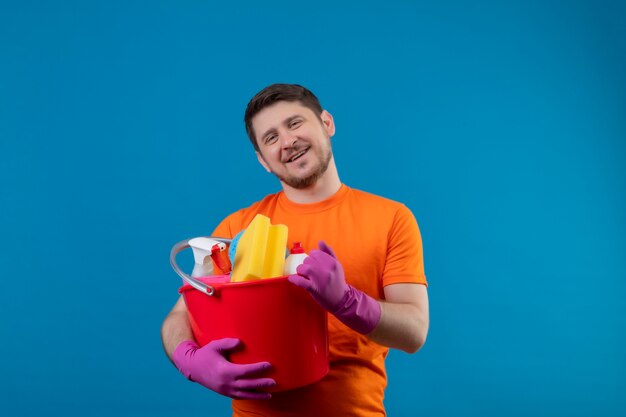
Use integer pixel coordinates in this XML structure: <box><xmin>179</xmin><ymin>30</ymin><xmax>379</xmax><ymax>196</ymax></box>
<box><xmin>213</xmin><ymin>185</ymin><xmax>426</xmax><ymax>417</ymax></box>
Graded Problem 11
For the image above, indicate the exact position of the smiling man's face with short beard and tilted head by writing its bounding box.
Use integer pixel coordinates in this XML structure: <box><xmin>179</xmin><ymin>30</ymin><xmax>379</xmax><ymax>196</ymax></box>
<box><xmin>252</xmin><ymin>101</ymin><xmax>335</xmax><ymax>189</ymax></box>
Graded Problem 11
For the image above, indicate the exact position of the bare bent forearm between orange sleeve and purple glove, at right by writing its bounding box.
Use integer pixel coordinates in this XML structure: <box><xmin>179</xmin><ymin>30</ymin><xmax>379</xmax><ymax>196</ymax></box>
<box><xmin>367</xmin><ymin>284</ymin><xmax>429</xmax><ymax>353</ymax></box>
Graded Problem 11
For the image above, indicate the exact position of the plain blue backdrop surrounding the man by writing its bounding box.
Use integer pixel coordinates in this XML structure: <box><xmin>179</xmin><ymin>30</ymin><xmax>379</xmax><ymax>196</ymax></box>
<box><xmin>0</xmin><ymin>1</ymin><xmax>626</xmax><ymax>417</ymax></box>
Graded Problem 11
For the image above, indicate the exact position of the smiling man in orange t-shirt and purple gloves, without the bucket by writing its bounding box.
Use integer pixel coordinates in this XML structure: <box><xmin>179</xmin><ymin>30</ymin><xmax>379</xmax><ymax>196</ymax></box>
<box><xmin>162</xmin><ymin>84</ymin><xmax>429</xmax><ymax>417</ymax></box>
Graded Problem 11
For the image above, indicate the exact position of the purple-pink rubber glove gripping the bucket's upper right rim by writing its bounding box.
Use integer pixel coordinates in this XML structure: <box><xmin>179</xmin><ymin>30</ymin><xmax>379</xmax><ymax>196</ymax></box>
<box><xmin>288</xmin><ymin>241</ymin><xmax>381</xmax><ymax>334</ymax></box>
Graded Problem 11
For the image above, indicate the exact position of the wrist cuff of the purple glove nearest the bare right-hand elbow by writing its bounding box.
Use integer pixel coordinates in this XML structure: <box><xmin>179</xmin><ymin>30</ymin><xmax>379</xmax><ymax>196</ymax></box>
<box><xmin>331</xmin><ymin>285</ymin><xmax>382</xmax><ymax>334</ymax></box>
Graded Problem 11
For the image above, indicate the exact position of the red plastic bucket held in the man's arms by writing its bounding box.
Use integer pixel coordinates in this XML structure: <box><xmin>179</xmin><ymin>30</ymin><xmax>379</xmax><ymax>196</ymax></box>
<box><xmin>179</xmin><ymin>277</ymin><xmax>328</xmax><ymax>392</ymax></box>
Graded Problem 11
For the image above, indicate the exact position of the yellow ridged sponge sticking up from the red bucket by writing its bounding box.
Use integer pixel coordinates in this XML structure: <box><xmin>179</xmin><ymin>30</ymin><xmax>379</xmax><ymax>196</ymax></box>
<box><xmin>231</xmin><ymin>214</ymin><xmax>287</xmax><ymax>282</ymax></box>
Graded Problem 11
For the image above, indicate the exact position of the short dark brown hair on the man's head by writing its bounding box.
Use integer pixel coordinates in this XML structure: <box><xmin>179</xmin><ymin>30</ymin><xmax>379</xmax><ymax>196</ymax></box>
<box><xmin>243</xmin><ymin>84</ymin><xmax>322</xmax><ymax>151</ymax></box>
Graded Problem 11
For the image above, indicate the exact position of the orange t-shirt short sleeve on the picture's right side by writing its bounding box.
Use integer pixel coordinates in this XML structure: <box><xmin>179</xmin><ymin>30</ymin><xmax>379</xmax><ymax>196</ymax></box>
<box><xmin>383</xmin><ymin>205</ymin><xmax>428</xmax><ymax>286</ymax></box>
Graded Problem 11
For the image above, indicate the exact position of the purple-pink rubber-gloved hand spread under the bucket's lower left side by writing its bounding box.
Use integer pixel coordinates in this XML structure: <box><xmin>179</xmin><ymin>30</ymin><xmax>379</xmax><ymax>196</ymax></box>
<box><xmin>172</xmin><ymin>338</ymin><xmax>276</xmax><ymax>400</ymax></box>
